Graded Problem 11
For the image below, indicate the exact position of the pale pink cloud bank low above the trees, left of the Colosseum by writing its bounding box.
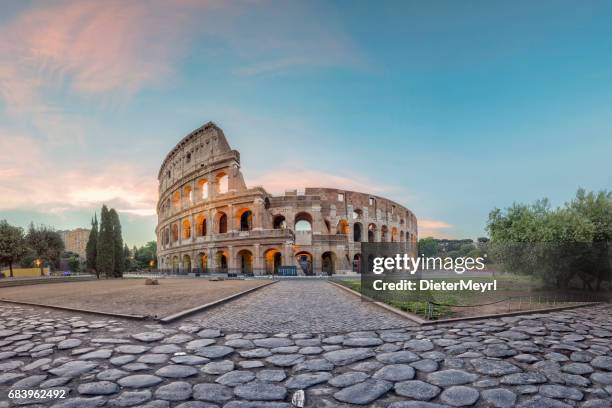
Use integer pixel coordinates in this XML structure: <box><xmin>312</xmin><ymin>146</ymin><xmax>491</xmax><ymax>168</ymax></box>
<box><xmin>0</xmin><ymin>129</ymin><xmax>157</xmax><ymax>215</ymax></box>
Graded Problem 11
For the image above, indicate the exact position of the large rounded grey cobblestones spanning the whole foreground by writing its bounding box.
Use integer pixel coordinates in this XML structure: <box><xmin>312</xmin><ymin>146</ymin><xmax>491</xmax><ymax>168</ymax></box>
<box><xmin>0</xmin><ymin>292</ymin><xmax>612</xmax><ymax>408</ymax></box>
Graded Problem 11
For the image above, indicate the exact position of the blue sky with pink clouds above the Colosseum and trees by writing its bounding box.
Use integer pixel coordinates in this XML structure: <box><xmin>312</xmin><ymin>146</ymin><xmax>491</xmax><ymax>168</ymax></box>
<box><xmin>0</xmin><ymin>0</ymin><xmax>612</xmax><ymax>245</ymax></box>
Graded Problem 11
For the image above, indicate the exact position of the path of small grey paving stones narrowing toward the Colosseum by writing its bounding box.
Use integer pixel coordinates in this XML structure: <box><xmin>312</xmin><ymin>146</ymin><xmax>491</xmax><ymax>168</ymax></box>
<box><xmin>188</xmin><ymin>280</ymin><xmax>413</xmax><ymax>333</ymax></box>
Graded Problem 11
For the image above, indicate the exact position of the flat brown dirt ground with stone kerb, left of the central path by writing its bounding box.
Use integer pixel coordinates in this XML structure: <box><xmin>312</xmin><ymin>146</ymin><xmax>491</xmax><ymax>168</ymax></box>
<box><xmin>0</xmin><ymin>279</ymin><xmax>268</xmax><ymax>318</ymax></box>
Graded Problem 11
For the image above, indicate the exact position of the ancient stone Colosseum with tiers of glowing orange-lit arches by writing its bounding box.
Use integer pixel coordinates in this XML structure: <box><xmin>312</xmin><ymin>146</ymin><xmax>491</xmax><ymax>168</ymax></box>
<box><xmin>156</xmin><ymin>122</ymin><xmax>417</xmax><ymax>275</ymax></box>
